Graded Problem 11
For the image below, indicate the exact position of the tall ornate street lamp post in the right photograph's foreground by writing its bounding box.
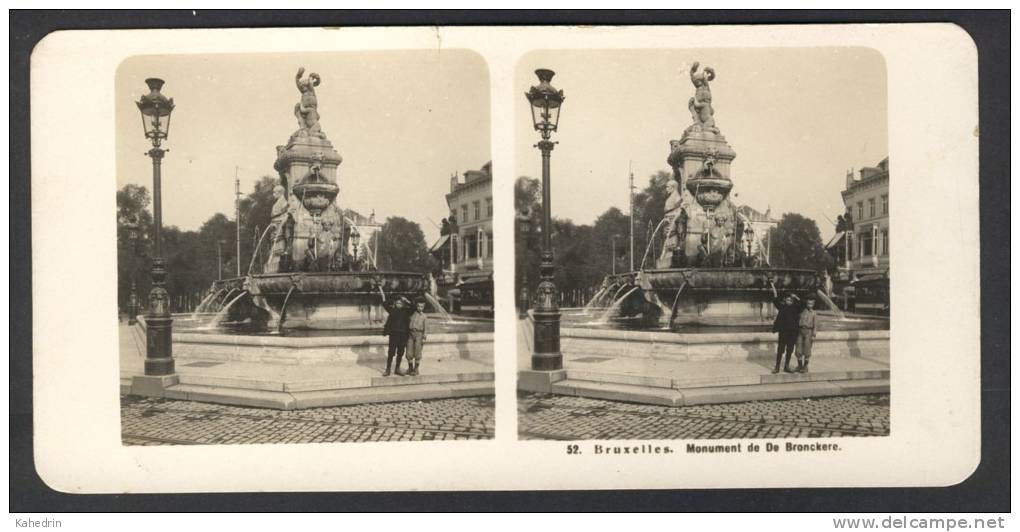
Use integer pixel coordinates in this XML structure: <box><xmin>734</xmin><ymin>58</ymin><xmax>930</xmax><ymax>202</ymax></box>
<box><xmin>524</xmin><ymin>68</ymin><xmax>564</xmax><ymax>371</ymax></box>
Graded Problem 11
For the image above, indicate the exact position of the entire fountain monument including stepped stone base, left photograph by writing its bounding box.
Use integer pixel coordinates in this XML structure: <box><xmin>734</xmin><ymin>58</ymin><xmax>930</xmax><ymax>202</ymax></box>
<box><xmin>121</xmin><ymin>68</ymin><xmax>495</xmax><ymax>410</ymax></box>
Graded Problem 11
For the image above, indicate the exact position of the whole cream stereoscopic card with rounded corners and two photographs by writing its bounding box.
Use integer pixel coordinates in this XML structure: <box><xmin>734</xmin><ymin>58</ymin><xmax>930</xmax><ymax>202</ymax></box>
<box><xmin>32</xmin><ymin>24</ymin><xmax>980</xmax><ymax>493</ymax></box>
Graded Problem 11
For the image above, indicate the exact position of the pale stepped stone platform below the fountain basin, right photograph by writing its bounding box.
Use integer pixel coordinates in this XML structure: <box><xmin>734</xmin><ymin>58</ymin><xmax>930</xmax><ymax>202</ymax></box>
<box><xmin>517</xmin><ymin>320</ymin><xmax>889</xmax><ymax>407</ymax></box>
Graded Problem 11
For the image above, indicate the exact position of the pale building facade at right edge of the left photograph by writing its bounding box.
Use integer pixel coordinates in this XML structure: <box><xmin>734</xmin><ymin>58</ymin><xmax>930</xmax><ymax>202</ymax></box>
<box><xmin>431</xmin><ymin>161</ymin><xmax>494</xmax><ymax>313</ymax></box>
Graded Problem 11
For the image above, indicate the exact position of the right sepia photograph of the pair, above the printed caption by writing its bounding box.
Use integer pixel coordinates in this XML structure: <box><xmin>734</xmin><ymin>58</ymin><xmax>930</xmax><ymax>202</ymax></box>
<box><xmin>514</xmin><ymin>47</ymin><xmax>890</xmax><ymax>440</ymax></box>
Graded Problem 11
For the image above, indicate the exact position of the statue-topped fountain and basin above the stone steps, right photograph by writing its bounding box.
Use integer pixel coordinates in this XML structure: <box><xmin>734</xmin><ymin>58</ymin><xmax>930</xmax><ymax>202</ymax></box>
<box><xmin>593</xmin><ymin>62</ymin><xmax>819</xmax><ymax>327</ymax></box>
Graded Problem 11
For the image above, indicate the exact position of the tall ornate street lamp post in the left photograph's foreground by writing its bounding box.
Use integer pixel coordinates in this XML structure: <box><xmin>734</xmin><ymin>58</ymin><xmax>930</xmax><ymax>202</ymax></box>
<box><xmin>136</xmin><ymin>77</ymin><xmax>173</xmax><ymax>376</ymax></box>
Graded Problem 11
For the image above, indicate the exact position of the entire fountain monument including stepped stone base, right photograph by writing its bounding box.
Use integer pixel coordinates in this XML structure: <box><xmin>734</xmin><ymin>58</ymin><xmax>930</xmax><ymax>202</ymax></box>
<box><xmin>517</xmin><ymin>63</ymin><xmax>889</xmax><ymax>406</ymax></box>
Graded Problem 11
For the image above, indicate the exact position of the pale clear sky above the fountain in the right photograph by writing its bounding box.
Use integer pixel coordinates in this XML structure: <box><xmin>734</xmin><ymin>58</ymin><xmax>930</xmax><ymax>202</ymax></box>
<box><xmin>515</xmin><ymin>48</ymin><xmax>888</xmax><ymax>241</ymax></box>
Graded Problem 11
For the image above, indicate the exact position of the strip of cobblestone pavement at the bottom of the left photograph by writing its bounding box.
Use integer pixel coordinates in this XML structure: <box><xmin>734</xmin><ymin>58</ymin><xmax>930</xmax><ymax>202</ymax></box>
<box><xmin>120</xmin><ymin>395</ymin><xmax>495</xmax><ymax>445</ymax></box>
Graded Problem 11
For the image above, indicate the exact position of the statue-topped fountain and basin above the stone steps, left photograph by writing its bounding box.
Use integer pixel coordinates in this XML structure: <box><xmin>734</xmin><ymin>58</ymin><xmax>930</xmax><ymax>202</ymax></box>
<box><xmin>199</xmin><ymin>68</ymin><xmax>428</xmax><ymax>329</ymax></box>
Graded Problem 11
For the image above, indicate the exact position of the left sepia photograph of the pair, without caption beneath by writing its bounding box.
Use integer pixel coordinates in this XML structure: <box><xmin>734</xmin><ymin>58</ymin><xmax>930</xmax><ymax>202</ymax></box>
<box><xmin>117</xmin><ymin>49</ymin><xmax>495</xmax><ymax>445</ymax></box>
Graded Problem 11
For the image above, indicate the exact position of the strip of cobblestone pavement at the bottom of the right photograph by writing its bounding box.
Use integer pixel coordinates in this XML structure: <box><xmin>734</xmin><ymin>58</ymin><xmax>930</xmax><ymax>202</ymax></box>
<box><xmin>517</xmin><ymin>392</ymin><xmax>889</xmax><ymax>439</ymax></box>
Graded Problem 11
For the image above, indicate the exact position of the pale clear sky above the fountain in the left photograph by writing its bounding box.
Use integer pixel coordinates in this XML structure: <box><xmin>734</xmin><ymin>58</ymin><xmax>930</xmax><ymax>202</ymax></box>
<box><xmin>115</xmin><ymin>49</ymin><xmax>492</xmax><ymax>245</ymax></box>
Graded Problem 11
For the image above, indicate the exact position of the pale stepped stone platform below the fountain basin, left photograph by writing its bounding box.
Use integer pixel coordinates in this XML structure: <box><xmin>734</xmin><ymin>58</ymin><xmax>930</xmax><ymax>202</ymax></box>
<box><xmin>119</xmin><ymin>324</ymin><xmax>494</xmax><ymax>410</ymax></box>
